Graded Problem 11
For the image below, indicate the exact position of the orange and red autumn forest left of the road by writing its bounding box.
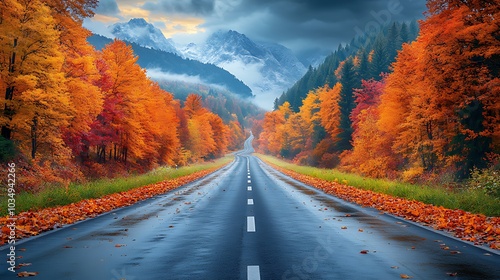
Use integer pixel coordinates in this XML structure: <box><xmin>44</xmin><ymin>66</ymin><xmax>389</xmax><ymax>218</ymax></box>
<box><xmin>0</xmin><ymin>0</ymin><xmax>245</xmax><ymax>191</ymax></box>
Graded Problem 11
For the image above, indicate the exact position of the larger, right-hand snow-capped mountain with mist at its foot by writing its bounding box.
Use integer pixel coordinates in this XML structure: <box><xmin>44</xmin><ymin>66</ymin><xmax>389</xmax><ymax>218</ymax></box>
<box><xmin>181</xmin><ymin>30</ymin><xmax>307</xmax><ymax>109</ymax></box>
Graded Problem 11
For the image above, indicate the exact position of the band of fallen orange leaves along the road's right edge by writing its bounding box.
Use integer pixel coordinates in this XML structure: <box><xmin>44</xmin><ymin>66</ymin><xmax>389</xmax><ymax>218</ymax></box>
<box><xmin>271</xmin><ymin>164</ymin><xmax>500</xmax><ymax>250</ymax></box>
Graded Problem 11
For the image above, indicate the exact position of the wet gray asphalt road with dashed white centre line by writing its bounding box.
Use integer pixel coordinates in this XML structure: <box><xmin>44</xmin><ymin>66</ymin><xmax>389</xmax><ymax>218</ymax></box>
<box><xmin>0</xmin><ymin>137</ymin><xmax>500</xmax><ymax>280</ymax></box>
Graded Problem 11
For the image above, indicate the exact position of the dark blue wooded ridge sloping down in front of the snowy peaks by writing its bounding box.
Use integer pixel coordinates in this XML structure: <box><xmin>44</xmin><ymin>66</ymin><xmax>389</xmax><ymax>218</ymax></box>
<box><xmin>88</xmin><ymin>35</ymin><xmax>253</xmax><ymax>97</ymax></box>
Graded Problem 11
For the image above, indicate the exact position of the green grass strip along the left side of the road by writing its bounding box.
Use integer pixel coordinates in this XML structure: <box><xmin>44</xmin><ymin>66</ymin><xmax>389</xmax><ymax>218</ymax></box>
<box><xmin>0</xmin><ymin>156</ymin><xmax>234</xmax><ymax>217</ymax></box>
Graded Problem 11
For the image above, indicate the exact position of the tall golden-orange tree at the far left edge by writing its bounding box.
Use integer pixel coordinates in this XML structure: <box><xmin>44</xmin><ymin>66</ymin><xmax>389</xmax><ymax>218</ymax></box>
<box><xmin>0</xmin><ymin>1</ymin><xmax>74</xmax><ymax>159</ymax></box>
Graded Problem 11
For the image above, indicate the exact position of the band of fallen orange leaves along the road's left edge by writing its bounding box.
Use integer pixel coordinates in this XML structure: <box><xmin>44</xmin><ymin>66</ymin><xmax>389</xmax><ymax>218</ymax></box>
<box><xmin>0</xmin><ymin>166</ymin><xmax>219</xmax><ymax>246</ymax></box>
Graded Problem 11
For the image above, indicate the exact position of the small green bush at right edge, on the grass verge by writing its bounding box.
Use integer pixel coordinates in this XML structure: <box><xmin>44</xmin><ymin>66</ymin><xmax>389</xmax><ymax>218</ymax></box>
<box><xmin>468</xmin><ymin>167</ymin><xmax>500</xmax><ymax>199</ymax></box>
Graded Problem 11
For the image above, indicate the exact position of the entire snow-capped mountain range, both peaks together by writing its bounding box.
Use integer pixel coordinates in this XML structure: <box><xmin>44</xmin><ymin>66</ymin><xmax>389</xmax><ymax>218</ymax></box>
<box><xmin>109</xmin><ymin>18</ymin><xmax>307</xmax><ymax>109</ymax></box>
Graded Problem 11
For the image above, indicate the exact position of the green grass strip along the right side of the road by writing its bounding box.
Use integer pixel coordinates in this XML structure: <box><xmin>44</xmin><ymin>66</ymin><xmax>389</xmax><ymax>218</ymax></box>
<box><xmin>257</xmin><ymin>154</ymin><xmax>500</xmax><ymax>217</ymax></box>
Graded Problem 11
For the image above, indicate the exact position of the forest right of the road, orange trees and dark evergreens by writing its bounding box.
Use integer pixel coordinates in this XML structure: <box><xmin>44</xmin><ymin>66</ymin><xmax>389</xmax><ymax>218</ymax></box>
<box><xmin>253</xmin><ymin>0</ymin><xmax>500</xmax><ymax>190</ymax></box>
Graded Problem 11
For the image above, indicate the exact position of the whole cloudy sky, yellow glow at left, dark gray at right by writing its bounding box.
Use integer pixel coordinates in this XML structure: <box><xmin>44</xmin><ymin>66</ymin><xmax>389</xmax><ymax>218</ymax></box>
<box><xmin>85</xmin><ymin>0</ymin><xmax>425</xmax><ymax>54</ymax></box>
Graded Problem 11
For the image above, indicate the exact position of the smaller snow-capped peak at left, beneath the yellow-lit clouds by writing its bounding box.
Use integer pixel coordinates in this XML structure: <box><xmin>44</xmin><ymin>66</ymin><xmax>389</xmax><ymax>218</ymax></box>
<box><xmin>109</xmin><ymin>18</ymin><xmax>179</xmax><ymax>54</ymax></box>
